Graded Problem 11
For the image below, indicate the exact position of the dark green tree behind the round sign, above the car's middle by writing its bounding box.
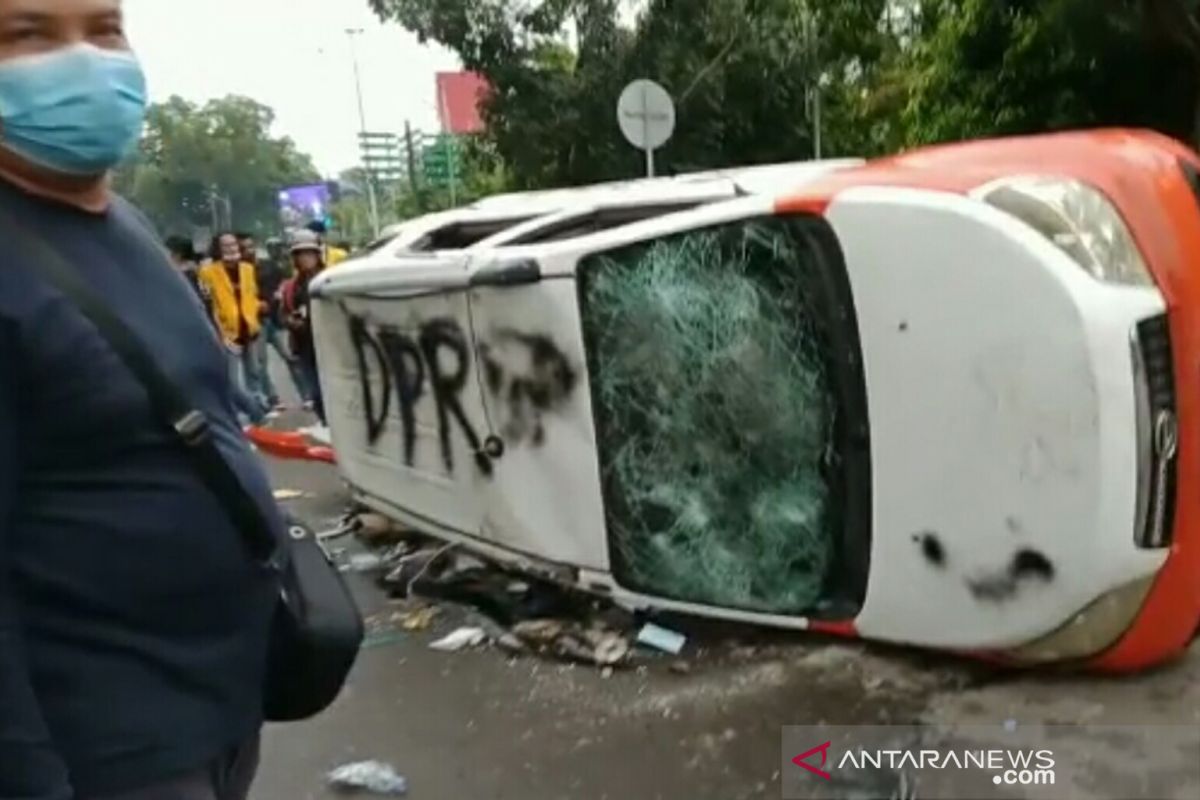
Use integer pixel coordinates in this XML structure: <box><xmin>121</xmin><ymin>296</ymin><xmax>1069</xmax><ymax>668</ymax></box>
<box><xmin>372</xmin><ymin>0</ymin><xmax>895</xmax><ymax>187</ymax></box>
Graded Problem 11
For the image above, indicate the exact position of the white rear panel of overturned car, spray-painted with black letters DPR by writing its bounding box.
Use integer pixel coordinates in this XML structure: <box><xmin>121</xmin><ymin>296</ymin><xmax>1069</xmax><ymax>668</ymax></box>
<box><xmin>313</xmin><ymin>255</ymin><xmax>491</xmax><ymax>536</ymax></box>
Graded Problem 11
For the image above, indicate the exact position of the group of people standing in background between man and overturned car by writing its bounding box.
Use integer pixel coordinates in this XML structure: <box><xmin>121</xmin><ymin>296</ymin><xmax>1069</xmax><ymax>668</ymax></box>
<box><xmin>167</xmin><ymin>222</ymin><xmax>348</xmax><ymax>425</ymax></box>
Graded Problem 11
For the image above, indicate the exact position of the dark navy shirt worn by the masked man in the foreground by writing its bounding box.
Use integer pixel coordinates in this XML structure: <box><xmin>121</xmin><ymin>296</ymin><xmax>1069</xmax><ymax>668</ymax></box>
<box><xmin>0</xmin><ymin>182</ymin><xmax>282</xmax><ymax>800</ymax></box>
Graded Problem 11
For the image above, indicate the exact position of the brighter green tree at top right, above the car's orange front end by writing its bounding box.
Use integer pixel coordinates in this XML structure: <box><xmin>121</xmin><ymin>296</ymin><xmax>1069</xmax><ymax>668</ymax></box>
<box><xmin>901</xmin><ymin>0</ymin><xmax>1200</xmax><ymax>144</ymax></box>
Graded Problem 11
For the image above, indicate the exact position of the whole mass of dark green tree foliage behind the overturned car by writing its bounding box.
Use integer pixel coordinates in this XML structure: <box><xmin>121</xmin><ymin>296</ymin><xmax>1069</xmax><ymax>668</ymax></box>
<box><xmin>371</xmin><ymin>0</ymin><xmax>1200</xmax><ymax>187</ymax></box>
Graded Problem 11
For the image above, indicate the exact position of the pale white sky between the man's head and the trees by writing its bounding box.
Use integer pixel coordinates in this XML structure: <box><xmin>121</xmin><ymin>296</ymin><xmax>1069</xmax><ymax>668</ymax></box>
<box><xmin>125</xmin><ymin>0</ymin><xmax>458</xmax><ymax>178</ymax></box>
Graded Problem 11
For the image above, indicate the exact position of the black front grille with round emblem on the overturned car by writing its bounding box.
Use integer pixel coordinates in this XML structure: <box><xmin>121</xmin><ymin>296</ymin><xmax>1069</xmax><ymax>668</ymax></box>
<box><xmin>1133</xmin><ymin>315</ymin><xmax>1180</xmax><ymax>548</ymax></box>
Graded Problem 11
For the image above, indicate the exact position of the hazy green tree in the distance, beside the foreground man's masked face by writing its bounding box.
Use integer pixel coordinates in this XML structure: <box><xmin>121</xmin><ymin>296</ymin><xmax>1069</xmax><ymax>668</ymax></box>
<box><xmin>116</xmin><ymin>96</ymin><xmax>320</xmax><ymax>236</ymax></box>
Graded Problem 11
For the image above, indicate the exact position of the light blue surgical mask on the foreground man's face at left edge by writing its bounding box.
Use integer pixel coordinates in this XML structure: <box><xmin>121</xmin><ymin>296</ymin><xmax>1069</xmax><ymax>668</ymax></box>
<box><xmin>0</xmin><ymin>44</ymin><xmax>146</xmax><ymax>175</ymax></box>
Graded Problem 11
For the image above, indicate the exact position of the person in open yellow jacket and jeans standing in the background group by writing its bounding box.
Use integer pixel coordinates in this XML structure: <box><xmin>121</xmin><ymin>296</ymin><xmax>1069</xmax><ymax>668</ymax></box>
<box><xmin>199</xmin><ymin>233</ymin><xmax>268</xmax><ymax>419</ymax></box>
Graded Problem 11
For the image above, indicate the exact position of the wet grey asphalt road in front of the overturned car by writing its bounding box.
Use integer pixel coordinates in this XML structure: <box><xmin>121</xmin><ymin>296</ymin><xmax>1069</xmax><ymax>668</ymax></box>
<box><xmin>254</xmin><ymin>443</ymin><xmax>1200</xmax><ymax>800</ymax></box>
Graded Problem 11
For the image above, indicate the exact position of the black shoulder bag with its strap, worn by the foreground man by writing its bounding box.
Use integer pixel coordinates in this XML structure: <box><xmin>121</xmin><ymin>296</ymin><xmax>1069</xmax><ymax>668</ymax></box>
<box><xmin>0</xmin><ymin>214</ymin><xmax>364</xmax><ymax>722</ymax></box>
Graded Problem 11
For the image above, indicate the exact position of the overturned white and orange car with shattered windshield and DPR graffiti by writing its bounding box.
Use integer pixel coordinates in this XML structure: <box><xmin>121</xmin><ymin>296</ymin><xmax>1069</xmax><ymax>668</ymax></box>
<box><xmin>314</xmin><ymin>131</ymin><xmax>1200</xmax><ymax>670</ymax></box>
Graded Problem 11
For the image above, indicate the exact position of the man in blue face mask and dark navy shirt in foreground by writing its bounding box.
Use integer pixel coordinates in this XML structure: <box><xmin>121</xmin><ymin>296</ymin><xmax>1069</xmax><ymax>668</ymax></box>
<box><xmin>0</xmin><ymin>0</ymin><xmax>282</xmax><ymax>800</ymax></box>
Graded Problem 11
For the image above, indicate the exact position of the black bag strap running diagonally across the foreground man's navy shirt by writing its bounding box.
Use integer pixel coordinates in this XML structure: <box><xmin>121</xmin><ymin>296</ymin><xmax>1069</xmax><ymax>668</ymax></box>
<box><xmin>0</xmin><ymin>212</ymin><xmax>277</xmax><ymax>561</ymax></box>
